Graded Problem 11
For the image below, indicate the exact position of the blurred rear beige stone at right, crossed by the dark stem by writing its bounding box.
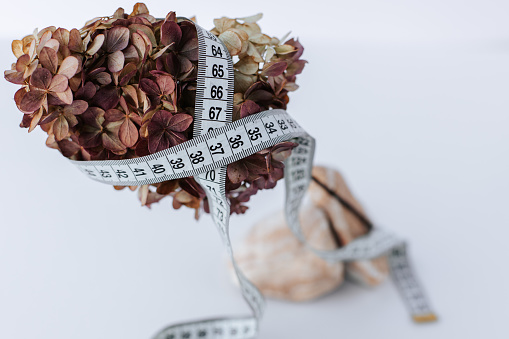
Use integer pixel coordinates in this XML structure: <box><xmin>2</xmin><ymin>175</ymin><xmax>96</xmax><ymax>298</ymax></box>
<box><xmin>307</xmin><ymin>166</ymin><xmax>389</xmax><ymax>286</ymax></box>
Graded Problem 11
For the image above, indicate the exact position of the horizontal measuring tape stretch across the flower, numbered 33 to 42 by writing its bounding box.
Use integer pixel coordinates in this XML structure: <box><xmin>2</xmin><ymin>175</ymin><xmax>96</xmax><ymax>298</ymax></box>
<box><xmin>71</xmin><ymin>109</ymin><xmax>307</xmax><ymax>186</ymax></box>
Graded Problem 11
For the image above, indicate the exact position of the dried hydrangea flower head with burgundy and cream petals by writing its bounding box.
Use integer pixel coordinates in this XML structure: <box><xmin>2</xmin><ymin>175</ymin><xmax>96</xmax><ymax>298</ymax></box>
<box><xmin>4</xmin><ymin>3</ymin><xmax>306</xmax><ymax>217</ymax></box>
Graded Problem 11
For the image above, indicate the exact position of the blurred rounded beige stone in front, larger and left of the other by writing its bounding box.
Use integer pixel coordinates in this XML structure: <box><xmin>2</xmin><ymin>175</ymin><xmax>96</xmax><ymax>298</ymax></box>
<box><xmin>230</xmin><ymin>205</ymin><xmax>344</xmax><ymax>301</ymax></box>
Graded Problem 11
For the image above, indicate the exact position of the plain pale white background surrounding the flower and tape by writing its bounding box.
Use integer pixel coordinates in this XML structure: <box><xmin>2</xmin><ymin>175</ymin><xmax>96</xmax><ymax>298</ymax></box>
<box><xmin>0</xmin><ymin>0</ymin><xmax>509</xmax><ymax>339</ymax></box>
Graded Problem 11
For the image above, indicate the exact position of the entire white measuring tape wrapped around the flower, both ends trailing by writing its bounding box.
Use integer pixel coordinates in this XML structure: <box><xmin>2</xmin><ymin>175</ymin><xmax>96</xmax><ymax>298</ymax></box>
<box><xmin>71</xmin><ymin>24</ymin><xmax>435</xmax><ymax>339</ymax></box>
